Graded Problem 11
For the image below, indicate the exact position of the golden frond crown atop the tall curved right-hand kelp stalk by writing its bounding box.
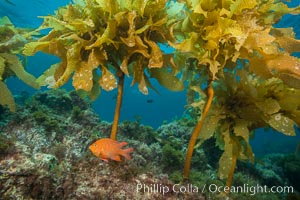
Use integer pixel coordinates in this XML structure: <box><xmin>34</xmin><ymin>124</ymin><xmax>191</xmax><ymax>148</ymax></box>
<box><xmin>170</xmin><ymin>0</ymin><xmax>300</xmax><ymax>85</ymax></box>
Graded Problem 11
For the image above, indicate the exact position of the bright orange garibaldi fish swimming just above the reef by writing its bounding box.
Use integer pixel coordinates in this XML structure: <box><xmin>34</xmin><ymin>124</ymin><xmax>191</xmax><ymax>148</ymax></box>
<box><xmin>89</xmin><ymin>138</ymin><xmax>133</xmax><ymax>162</ymax></box>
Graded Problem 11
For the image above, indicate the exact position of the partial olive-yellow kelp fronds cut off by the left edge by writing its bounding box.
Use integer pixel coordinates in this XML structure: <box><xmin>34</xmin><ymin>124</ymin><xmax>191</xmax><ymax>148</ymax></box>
<box><xmin>0</xmin><ymin>17</ymin><xmax>39</xmax><ymax>111</ymax></box>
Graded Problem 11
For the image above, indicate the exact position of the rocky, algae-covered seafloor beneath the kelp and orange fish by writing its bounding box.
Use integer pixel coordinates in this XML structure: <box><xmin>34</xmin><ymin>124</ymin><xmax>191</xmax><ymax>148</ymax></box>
<box><xmin>0</xmin><ymin>90</ymin><xmax>300</xmax><ymax>200</ymax></box>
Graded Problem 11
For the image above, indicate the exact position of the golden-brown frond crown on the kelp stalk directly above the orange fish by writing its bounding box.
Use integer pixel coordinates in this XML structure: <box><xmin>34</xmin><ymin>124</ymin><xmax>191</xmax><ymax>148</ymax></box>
<box><xmin>24</xmin><ymin>0</ymin><xmax>183</xmax><ymax>95</ymax></box>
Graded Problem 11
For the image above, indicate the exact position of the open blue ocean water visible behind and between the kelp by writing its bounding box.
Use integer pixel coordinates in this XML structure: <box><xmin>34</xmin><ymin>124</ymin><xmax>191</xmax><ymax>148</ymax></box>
<box><xmin>0</xmin><ymin>0</ymin><xmax>300</xmax><ymax>155</ymax></box>
